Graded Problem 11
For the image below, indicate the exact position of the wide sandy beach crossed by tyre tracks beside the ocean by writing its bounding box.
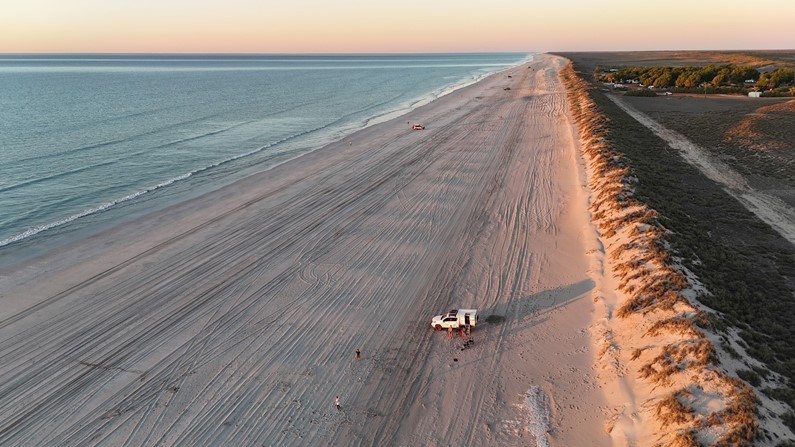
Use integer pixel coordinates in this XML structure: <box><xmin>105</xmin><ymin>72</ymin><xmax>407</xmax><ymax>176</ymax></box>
<box><xmin>0</xmin><ymin>55</ymin><xmax>616</xmax><ymax>446</ymax></box>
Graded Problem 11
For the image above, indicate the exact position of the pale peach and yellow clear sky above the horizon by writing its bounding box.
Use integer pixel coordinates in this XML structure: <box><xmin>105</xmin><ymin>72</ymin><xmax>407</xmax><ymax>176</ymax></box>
<box><xmin>0</xmin><ymin>0</ymin><xmax>795</xmax><ymax>53</ymax></box>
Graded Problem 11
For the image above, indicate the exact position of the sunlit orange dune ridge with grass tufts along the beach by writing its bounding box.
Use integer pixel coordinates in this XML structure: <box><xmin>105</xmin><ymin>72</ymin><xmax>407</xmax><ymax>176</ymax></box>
<box><xmin>561</xmin><ymin>64</ymin><xmax>759</xmax><ymax>446</ymax></box>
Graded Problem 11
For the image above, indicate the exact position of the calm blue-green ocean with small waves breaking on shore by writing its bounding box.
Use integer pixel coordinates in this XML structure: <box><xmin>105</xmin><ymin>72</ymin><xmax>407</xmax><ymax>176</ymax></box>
<box><xmin>0</xmin><ymin>53</ymin><xmax>530</xmax><ymax>260</ymax></box>
